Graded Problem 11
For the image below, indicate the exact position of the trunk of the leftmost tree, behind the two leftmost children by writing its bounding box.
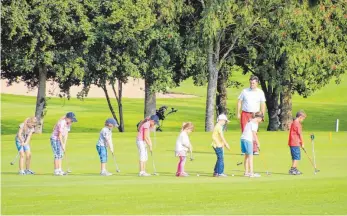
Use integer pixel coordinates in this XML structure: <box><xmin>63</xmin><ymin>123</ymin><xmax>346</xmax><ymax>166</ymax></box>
<box><xmin>35</xmin><ymin>65</ymin><xmax>47</xmax><ymax>133</ymax></box>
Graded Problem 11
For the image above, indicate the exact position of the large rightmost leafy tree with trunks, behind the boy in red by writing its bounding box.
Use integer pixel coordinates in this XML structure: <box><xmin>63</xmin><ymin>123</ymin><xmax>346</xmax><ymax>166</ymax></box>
<box><xmin>246</xmin><ymin>1</ymin><xmax>346</xmax><ymax>130</ymax></box>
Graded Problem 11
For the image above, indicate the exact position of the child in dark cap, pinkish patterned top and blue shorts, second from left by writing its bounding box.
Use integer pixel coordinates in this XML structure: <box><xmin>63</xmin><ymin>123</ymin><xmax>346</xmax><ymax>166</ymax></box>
<box><xmin>51</xmin><ymin>112</ymin><xmax>77</xmax><ymax>176</ymax></box>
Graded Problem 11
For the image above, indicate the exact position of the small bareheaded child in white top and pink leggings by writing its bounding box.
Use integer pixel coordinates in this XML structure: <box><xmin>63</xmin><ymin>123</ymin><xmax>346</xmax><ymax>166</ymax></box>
<box><xmin>175</xmin><ymin>122</ymin><xmax>194</xmax><ymax>177</ymax></box>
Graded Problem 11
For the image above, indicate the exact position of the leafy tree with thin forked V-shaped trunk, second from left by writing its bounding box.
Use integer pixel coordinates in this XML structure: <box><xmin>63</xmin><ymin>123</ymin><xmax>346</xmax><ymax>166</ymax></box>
<box><xmin>80</xmin><ymin>0</ymin><xmax>154</xmax><ymax>132</ymax></box>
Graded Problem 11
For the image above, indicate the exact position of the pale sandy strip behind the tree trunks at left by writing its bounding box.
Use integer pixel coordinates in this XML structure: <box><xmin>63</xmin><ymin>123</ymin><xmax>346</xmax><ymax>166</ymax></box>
<box><xmin>1</xmin><ymin>79</ymin><xmax>197</xmax><ymax>98</ymax></box>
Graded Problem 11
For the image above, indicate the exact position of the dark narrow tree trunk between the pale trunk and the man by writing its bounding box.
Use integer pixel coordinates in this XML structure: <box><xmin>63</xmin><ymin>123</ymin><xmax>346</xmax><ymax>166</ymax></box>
<box><xmin>216</xmin><ymin>71</ymin><xmax>228</xmax><ymax>115</ymax></box>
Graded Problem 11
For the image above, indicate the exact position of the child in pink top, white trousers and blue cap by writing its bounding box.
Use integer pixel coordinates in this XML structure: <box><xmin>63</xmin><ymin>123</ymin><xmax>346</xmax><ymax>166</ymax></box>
<box><xmin>136</xmin><ymin>115</ymin><xmax>159</xmax><ymax>176</ymax></box>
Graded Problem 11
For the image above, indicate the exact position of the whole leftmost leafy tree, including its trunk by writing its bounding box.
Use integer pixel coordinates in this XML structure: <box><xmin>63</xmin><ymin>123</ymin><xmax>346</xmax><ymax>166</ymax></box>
<box><xmin>1</xmin><ymin>0</ymin><xmax>90</xmax><ymax>132</ymax></box>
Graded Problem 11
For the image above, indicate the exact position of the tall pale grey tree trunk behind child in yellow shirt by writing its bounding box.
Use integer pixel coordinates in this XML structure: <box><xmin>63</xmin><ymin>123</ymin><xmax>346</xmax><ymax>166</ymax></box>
<box><xmin>205</xmin><ymin>42</ymin><xmax>218</xmax><ymax>131</ymax></box>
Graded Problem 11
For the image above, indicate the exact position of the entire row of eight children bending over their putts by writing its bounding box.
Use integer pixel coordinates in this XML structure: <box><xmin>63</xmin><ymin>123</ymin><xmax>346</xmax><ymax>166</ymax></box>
<box><xmin>15</xmin><ymin>111</ymin><xmax>306</xmax><ymax>178</ymax></box>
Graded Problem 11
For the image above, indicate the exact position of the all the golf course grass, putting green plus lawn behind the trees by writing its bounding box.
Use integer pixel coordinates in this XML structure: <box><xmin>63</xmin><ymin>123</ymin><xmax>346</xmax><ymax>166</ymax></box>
<box><xmin>1</xmin><ymin>74</ymin><xmax>347</xmax><ymax>215</ymax></box>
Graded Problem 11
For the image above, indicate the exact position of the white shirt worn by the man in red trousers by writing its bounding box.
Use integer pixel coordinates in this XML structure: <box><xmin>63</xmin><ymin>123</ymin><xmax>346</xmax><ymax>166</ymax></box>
<box><xmin>239</xmin><ymin>88</ymin><xmax>266</xmax><ymax>112</ymax></box>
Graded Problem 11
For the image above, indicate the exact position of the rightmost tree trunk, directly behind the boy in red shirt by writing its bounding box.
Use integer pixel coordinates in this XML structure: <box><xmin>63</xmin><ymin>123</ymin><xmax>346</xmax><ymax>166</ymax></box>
<box><xmin>280</xmin><ymin>86</ymin><xmax>293</xmax><ymax>131</ymax></box>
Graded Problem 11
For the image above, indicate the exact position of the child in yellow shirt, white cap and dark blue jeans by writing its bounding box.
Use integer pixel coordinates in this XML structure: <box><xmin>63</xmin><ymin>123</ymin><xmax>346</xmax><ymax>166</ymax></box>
<box><xmin>212</xmin><ymin>114</ymin><xmax>230</xmax><ymax>177</ymax></box>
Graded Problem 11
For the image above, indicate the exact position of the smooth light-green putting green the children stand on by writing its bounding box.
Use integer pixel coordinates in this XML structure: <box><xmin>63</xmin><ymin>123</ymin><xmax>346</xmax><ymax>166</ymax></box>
<box><xmin>1</xmin><ymin>131</ymin><xmax>347</xmax><ymax>215</ymax></box>
